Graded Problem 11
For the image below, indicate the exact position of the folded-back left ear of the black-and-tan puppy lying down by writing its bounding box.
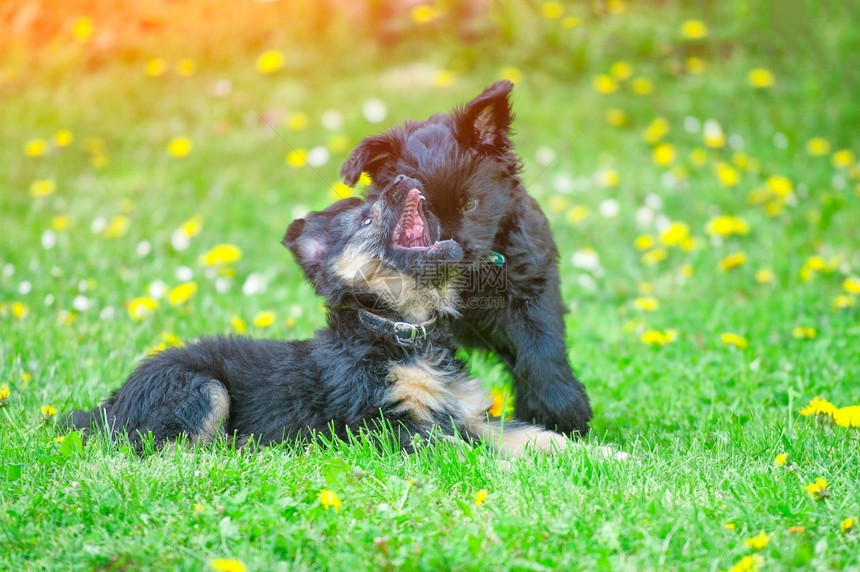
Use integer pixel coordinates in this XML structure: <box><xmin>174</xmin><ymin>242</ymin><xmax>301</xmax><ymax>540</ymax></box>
<box><xmin>281</xmin><ymin>197</ymin><xmax>363</xmax><ymax>279</ymax></box>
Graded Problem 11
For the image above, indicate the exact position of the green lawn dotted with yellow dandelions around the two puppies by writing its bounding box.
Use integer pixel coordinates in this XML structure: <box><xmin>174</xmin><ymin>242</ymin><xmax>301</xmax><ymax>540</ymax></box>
<box><xmin>0</xmin><ymin>0</ymin><xmax>860</xmax><ymax>570</ymax></box>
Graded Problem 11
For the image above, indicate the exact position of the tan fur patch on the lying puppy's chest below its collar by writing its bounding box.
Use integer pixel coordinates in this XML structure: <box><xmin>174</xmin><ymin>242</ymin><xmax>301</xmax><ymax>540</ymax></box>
<box><xmin>388</xmin><ymin>361</ymin><xmax>454</xmax><ymax>424</ymax></box>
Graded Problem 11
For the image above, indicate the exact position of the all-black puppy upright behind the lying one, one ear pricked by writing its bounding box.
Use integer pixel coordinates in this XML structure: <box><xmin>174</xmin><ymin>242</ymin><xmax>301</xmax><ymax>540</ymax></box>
<box><xmin>341</xmin><ymin>81</ymin><xmax>592</xmax><ymax>435</ymax></box>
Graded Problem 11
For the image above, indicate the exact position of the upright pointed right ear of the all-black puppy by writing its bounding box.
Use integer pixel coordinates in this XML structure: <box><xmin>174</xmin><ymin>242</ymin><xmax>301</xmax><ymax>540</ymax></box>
<box><xmin>456</xmin><ymin>80</ymin><xmax>514</xmax><ymax>153</ymax></box>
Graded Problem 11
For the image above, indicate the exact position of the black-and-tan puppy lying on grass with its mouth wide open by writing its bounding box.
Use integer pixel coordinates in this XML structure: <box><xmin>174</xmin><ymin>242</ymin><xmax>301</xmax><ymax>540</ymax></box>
<box><xmin>65</xmin><ymin>177</ymin><xmax>567</xmax><ymax>455</ymax></box>
